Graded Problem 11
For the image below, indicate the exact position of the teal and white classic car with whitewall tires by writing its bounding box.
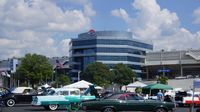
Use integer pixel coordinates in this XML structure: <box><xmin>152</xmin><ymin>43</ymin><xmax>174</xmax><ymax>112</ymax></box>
<box><xmin>32</xmin><ymin>88</ymin><xmax>96</xmax><ymax>110</ymax></box>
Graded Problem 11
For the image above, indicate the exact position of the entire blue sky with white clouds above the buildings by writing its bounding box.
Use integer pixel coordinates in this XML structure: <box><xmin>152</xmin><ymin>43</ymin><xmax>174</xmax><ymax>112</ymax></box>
<box><xmin>0</xmin><ymin>0</ymin><xmax>200</xmax><ymax>60</ymax></box>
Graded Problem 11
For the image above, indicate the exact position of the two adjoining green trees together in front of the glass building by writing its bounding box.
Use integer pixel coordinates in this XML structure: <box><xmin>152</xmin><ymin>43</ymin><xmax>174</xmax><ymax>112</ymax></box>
<box><xmin>82</xmin><ymin>62</ymin><xmax>136</xmax><ymax>86</ymax></box>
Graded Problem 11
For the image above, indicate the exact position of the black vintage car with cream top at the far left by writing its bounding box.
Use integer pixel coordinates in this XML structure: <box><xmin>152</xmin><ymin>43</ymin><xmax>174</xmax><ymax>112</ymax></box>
<box><xmin>0</xmin><ymin>87</ymin><xmax>37</xmax><ymax>107</ymax></box>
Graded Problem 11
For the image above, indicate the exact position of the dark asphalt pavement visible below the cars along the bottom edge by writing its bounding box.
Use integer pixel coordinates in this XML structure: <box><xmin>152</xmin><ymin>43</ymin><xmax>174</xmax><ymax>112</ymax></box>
<box><xmin>0</xmin><ymin>104</ymin><xmax>198</xmax><ymax>112</ymax></box>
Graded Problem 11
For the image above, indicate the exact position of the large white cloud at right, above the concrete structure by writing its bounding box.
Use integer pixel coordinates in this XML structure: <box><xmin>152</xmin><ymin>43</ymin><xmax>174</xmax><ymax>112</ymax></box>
<box><xmin>111</xmin><ymin>0</ymin><xmax>200</xmax><ymax>50</ymax></box>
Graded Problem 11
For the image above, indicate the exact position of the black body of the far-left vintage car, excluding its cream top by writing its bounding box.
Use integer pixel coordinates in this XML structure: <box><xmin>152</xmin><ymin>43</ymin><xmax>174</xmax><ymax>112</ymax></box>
<box><xmin>0</xmin><ymin>87</ymin><xmax>37</xmax><ymax>107</ymax></box>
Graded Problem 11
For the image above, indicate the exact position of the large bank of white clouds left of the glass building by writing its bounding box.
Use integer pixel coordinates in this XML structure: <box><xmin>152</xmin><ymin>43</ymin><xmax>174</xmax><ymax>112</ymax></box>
<box><xmin>0</xmin><ymin>0</ymin><xmax>96</xmax><ymax>59</ymax></box>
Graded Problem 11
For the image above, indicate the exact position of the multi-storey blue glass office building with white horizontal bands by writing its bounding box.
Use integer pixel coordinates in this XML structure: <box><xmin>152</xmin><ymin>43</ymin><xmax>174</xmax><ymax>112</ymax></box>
<box><xmin>70</xmin><ymin>31</ymin><xmax>153</xmax><ymax>79</ymax></box>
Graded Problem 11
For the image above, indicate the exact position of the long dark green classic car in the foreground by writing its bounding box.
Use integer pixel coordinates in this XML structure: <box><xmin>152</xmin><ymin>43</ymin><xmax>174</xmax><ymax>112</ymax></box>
<box><xmin>82</xmin><ymin>93</ymin><xmax>175</xmax><ymax>112</ymax></box>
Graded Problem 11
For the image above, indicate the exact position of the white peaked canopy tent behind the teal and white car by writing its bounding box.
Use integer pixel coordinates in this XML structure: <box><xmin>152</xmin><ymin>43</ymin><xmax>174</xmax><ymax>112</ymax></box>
<box><xmin>63</xmin><ymin>80</ymin><xmax>103</xmax><ymax>89</ymax></box>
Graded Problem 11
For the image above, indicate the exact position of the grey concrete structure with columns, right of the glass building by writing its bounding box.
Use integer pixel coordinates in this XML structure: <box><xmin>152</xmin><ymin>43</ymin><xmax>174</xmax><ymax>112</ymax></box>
<box><xmin>143</xmin><ymin>50</ymin><xmax>200</xmax><ymax>79</ymax></box>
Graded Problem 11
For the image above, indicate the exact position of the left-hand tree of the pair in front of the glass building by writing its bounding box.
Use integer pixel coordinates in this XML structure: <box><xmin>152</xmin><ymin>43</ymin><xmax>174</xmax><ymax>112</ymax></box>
<box><xmin>82</xmin><ymin>62</ymin><xmax>111</xmax><ymax>86</ymax></box>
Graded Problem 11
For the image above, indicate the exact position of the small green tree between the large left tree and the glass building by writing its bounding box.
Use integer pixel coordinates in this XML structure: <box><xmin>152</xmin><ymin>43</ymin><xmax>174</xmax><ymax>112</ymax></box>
<box><xmin>56</xmin><ymin>74</ymin><xmax>71</xmax><ymax>86</ymax></box>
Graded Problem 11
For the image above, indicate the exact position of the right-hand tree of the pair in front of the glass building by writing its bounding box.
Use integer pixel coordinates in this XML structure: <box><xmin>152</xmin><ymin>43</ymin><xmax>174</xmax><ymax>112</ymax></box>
<box><xmin>113</xmin><ymin>64</ymin><xmax>136</xmax><ymax>85</ymax></box>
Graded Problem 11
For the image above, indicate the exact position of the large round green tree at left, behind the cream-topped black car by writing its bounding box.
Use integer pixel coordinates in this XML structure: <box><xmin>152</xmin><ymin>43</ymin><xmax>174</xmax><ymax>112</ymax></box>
<box><xmin>16</xmin><ymin>54</ymin><xmax>53</xmax><ymax>87</ymax></box>
